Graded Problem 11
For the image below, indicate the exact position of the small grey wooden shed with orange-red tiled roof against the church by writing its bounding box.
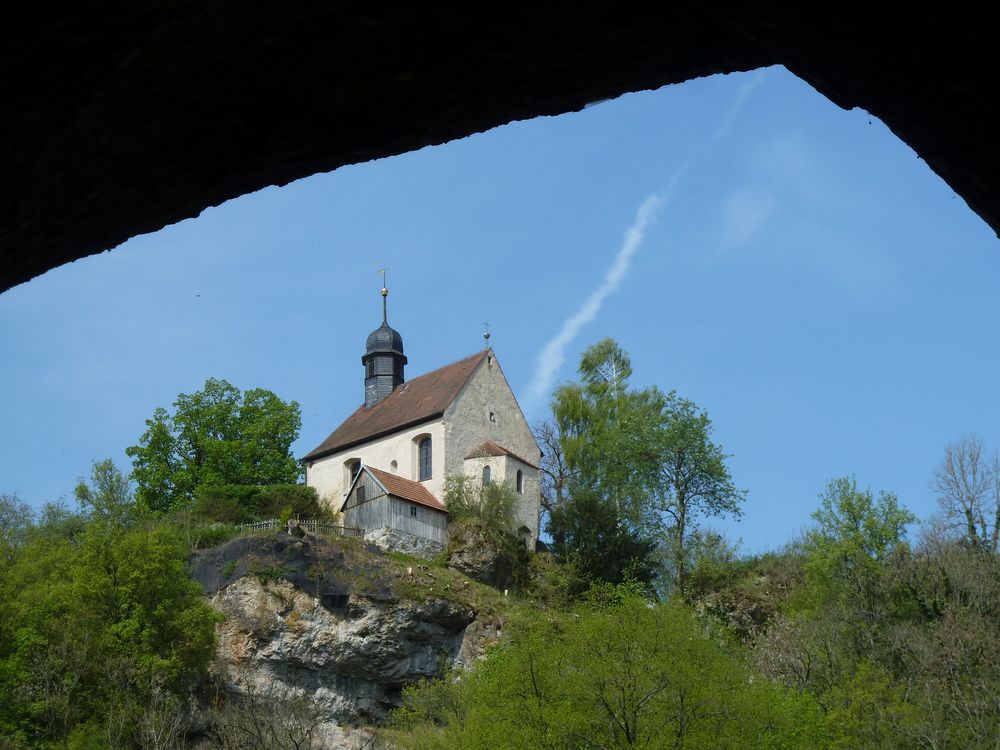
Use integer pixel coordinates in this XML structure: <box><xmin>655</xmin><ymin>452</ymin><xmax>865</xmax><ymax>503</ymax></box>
<box><xmin>340</xmin><ymin>465</ymin><xmax>448</xmax><ymax>545</ymax></box>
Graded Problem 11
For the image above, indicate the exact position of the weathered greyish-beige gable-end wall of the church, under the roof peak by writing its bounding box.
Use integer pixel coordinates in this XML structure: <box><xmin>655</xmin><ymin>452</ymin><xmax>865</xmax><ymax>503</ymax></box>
<box><xmin>444</xmin><ymin>353</ymin><xmax>542</xmax><ymax>542</ymax></box>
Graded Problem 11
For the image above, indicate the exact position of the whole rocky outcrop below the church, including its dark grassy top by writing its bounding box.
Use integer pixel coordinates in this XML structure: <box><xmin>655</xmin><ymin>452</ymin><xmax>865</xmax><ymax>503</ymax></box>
<box><xmin>191</xmin><ymin>532</ymin><xmax>499</xmax><ymax>747</ymax></box>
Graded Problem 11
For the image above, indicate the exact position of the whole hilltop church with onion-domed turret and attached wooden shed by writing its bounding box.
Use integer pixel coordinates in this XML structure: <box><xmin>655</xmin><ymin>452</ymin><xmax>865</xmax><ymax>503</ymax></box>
<box><xmin>303</xmin><ymin>287</ymin><xmax>542</xmax><ymax>551</ymax></box>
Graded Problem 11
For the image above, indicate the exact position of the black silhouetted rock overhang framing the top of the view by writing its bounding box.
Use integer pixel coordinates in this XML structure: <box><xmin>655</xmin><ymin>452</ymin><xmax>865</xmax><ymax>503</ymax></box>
<box><xmin>0</xmin><ymin>0</ymin><xmax>1000</xmax><ymax>290</ymax></box>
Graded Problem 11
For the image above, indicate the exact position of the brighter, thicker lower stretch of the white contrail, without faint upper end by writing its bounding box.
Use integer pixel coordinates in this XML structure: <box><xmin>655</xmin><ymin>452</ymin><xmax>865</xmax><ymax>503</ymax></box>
<box><xmin>528</xmin><ymin>172</ymin><xmax>684</xmax><ymax>411</ymax></box>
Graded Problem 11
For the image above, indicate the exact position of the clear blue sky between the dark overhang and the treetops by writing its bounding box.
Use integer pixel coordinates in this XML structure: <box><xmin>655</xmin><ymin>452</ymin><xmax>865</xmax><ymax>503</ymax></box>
<box><xmin>0</xmin><ymin>68</ymin><xmax>1000</xmax><ymax>550</ymax></box>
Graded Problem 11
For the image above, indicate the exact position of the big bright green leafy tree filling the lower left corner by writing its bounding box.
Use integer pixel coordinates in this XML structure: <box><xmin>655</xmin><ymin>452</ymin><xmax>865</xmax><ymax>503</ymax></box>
<box><xmin>0</xmin><ymin>512</ymin><xmax>217</xmax><ymax>747</ymax></box>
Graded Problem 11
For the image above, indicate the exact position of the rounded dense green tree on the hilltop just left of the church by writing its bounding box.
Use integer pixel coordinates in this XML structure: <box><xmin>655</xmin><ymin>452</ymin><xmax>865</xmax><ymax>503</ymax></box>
<box><xmin>126</xmin><ymin>378</ymin><xmax>302</xmax><ymax>512</ymax></box>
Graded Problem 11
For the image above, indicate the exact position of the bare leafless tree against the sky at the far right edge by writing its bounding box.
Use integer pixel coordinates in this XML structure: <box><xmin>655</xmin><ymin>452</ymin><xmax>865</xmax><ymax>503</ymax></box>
<box><xmin>931</xmin><ymin>435</ymin><xmax>1000</xmax><ymax>552</ymax></box>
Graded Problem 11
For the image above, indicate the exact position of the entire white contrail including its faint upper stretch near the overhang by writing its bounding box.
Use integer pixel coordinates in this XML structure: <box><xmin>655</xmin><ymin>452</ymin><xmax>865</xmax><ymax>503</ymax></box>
<box><xmin>525</xmin><ymin>71</ymin><xmax>766</xmax><ymax>414</ymax></box>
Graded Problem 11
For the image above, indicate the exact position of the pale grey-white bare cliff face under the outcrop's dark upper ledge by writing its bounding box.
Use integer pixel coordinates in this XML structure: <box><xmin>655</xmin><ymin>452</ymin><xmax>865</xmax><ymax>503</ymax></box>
<box><xmin>212</xmin><ymin>576</ymin><xmax>475</xmax><ymax>724</ymax></box>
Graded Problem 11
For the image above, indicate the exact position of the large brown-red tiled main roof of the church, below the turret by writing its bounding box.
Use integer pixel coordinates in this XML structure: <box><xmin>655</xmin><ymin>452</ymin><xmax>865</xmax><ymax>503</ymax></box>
<box><xmin>303</xmin><ymin>350</ymin><xmax>488</xmax><ymax>461</ymax></box>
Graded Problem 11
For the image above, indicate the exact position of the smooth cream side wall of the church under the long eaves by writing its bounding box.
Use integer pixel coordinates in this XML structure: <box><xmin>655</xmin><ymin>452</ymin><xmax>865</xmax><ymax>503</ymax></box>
<box><xmin>306</xmin><ymin>419</ymin><xmax>445</xmax><ymax>510</ymax></box>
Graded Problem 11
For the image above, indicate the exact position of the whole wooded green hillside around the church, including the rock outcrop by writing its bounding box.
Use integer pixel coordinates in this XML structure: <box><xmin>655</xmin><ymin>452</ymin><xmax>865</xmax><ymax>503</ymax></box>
<box><xmin>0</xmin><ymin>350</ymin><xmax>1000</xmax><ymax>750</ymax></box>
